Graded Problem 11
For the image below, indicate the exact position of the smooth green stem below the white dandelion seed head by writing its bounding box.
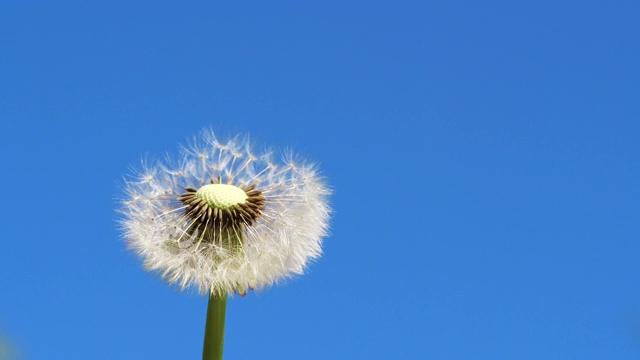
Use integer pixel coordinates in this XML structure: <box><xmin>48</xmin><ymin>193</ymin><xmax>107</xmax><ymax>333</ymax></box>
<box><xmin>202</xmin><ymin>294</ymin><xmax>227</xmax><ymax>360</ymax></box>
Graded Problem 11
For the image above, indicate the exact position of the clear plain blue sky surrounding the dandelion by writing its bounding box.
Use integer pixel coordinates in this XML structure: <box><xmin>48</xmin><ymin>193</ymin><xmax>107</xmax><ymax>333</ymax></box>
<box><xmin>0</xmin><ymin>0</ymin><xmax>640</xmax><ymax>360</ymax></box>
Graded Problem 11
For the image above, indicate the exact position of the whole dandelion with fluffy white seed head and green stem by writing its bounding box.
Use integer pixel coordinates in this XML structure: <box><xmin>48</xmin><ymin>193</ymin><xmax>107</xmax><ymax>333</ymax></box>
<box><xmin>120</xmin><ymin>131</ymin><xmax>330</xmax><ymax>358</ymax></box>
